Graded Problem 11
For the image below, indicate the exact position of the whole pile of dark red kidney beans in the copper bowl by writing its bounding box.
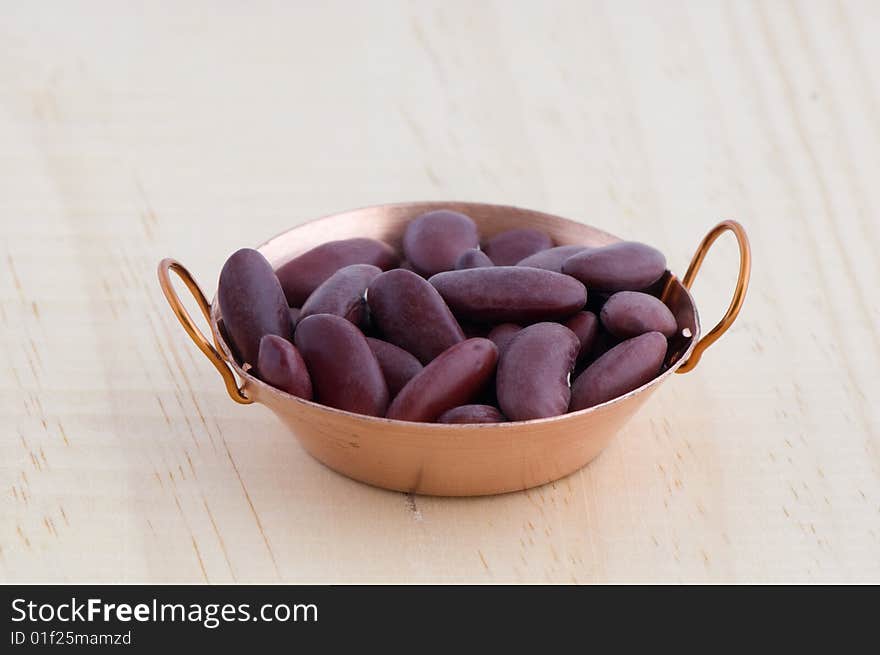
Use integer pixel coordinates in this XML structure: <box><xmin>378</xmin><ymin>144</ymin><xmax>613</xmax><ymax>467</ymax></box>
<box><xmin>219</xmin><ymin>210</ymin><xmax>677</xmax><ymax>423</ymax></box>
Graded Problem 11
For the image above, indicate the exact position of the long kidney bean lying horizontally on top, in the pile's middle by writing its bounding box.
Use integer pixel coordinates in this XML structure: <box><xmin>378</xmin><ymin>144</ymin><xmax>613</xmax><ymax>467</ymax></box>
<box><xmin>428</xmin><ymin>266</ymin><xmax>587</xmax><ymax>323</ymax></box>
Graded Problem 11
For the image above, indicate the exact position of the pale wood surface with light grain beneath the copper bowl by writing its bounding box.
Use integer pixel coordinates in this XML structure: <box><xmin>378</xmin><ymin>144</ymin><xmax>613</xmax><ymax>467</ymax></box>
<box><xmin>0</xmin><ymin>0</ymin><xmax>880</xmax><ymax>582</ymax></box>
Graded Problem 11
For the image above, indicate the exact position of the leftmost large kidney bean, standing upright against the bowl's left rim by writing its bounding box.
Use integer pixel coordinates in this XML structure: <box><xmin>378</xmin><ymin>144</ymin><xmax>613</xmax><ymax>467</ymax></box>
<box><xmin>217</xmin><ymin>248</ymin><xmax>293</xmax><ymax>366</ymax></box>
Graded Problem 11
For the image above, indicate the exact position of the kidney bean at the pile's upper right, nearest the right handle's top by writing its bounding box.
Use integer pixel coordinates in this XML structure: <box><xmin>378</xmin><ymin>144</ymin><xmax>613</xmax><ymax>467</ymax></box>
<box><xmin>562</xmin><ymin>241</ymin><xmax>666</xmax><ymax>291</ymax></box>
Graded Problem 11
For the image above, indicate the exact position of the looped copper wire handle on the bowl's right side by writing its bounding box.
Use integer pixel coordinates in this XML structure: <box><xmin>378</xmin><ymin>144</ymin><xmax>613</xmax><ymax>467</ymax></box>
<box><xmin>676</xmin><ymin>221</ymin><xmax>752</xmax><ymax>373</ymax></box>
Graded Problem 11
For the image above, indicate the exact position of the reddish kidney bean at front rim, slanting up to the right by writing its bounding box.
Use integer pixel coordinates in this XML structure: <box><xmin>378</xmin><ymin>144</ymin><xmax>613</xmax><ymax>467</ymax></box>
<box><xmin>386</xmin><ymin>338</ymin><xmax>498</xmax><ymax>422</ymax></box>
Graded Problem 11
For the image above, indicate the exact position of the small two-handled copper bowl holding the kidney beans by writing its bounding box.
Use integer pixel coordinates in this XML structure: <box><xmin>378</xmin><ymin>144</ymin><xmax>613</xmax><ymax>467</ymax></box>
<box><xmin>159</xmin><ymin>202</ymin><xmax>750</xmax><ymax>496</ymax></box>
